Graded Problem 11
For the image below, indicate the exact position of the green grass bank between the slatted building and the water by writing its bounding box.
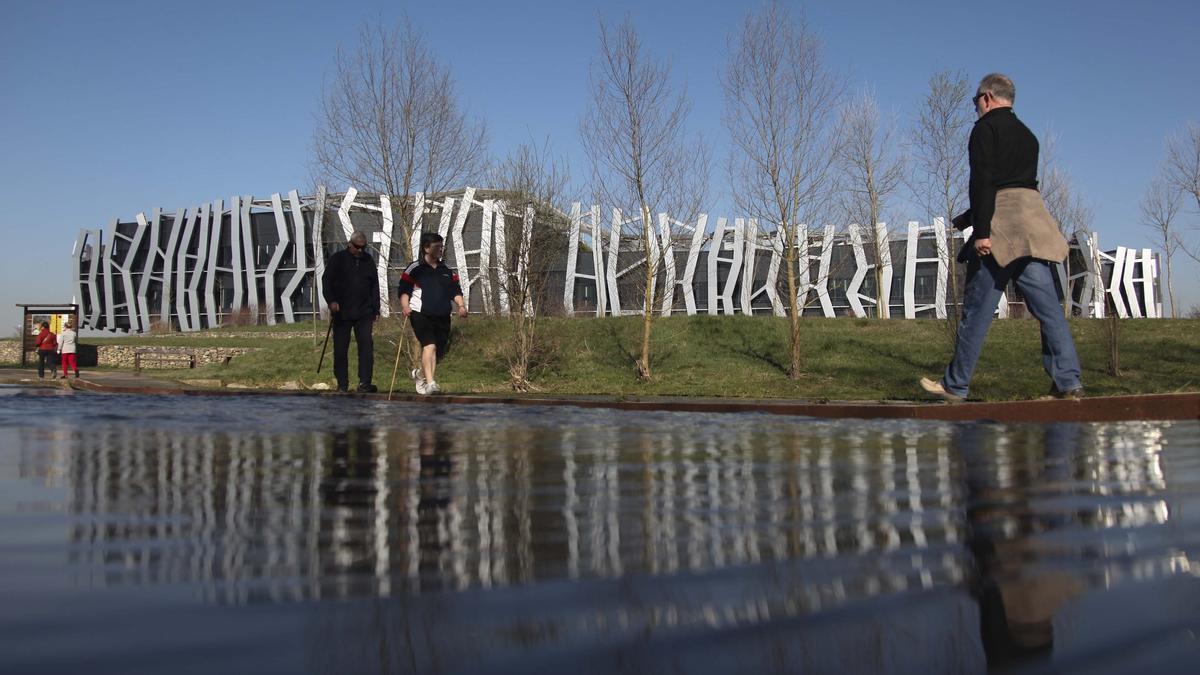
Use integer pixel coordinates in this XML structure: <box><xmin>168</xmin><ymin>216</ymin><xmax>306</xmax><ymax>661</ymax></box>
<box><xmin>86</xmin><ymin>316</ymin><xmax>1200</xmax><ymax>401</ymax></box>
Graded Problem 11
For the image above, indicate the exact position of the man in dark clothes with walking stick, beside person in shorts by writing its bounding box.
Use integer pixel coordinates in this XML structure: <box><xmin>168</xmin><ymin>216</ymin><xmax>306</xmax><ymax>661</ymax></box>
<box><xmin>322</xmin><ymin>232</ymin><xmax>379</xmax><ymax>392</ymax></box>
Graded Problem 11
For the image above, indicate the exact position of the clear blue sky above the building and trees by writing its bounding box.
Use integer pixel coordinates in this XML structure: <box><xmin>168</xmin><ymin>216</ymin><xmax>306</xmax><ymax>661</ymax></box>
<box><xmin>0</xmin><ymin>0</ymin><xmax>1200</xmax><ymax>333</ymax></box>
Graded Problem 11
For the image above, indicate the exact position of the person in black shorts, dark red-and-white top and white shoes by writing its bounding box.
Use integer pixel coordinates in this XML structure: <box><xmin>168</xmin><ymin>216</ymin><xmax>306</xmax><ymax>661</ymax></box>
<box><xmin>400</xmin><ymin>232</ymin><xmax>467</xmax><ymax>394</ymax></box>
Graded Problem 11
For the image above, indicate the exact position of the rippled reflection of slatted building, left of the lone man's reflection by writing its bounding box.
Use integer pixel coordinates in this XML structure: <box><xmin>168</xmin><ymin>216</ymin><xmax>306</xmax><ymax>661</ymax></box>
<box><xmin>54</xmin><ymin>415</ymin><xmax>964</xmax><ymax>598</ymax></box>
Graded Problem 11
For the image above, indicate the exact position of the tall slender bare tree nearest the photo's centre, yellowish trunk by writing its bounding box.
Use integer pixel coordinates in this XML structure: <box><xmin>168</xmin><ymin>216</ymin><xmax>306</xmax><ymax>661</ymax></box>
<box><xmin>581</xmin><ymin>17</ymin><xmax>708</xmax><ymax>380</ymax></box>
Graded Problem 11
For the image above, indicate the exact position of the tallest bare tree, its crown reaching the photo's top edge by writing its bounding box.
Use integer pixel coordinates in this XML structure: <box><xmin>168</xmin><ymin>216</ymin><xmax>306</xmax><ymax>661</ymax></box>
<box><xmin>721</xmin><ymin>2</ymin><xmax>842</xmax><ymax>378</ymax></box>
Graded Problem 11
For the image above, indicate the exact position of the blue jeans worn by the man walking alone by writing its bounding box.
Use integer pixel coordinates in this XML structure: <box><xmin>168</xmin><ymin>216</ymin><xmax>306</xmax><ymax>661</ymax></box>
<box><xmin>942</xmin><ymin>251</ymin><xmax>1080</xmax><ymax>398</ymax></box>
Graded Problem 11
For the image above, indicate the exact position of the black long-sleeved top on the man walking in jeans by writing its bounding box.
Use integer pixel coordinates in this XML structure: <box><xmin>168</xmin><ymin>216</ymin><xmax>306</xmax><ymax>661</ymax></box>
<box><xmin>954</xmin><ymin>108</ymin><xmax>1038</xmax><ymax>239</ymax></box>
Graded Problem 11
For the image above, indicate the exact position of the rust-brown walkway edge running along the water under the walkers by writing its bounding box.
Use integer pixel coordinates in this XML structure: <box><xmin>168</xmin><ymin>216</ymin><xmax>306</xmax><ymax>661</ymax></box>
<box><xmin>0</xmin><ymin>369</ymin><xmax>1200</xmax><ymax>423</ymax></box>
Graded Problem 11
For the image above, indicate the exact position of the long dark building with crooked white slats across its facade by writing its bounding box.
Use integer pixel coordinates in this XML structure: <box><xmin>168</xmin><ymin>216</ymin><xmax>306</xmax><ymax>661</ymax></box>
<box><xmin>73</xmin><ymin>187</ymin><xmax>1162</xmax><ymax>331</ymax></box>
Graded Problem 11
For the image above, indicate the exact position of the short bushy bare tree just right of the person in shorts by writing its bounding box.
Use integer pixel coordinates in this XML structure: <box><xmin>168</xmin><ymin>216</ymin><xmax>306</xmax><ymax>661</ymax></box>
<box><xmin>492</xmin><ymin>141</ymin><xmax>570</xmax><ymax>392</ymax></box>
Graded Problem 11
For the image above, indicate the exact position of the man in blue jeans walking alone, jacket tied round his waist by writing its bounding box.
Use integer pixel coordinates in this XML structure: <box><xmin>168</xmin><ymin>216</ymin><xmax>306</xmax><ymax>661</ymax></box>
<box><xmin>920</xmin><ymin>73</ymin><xmax>1084</xmax><ymax>401</ymax></box>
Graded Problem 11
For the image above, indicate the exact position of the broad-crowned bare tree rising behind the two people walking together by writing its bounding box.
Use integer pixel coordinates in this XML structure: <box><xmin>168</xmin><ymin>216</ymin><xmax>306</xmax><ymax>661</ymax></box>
<box><xmin>313</xmin><ymin>18</ymin><xmax>487</xmax><ymax>261</ymax></box>
